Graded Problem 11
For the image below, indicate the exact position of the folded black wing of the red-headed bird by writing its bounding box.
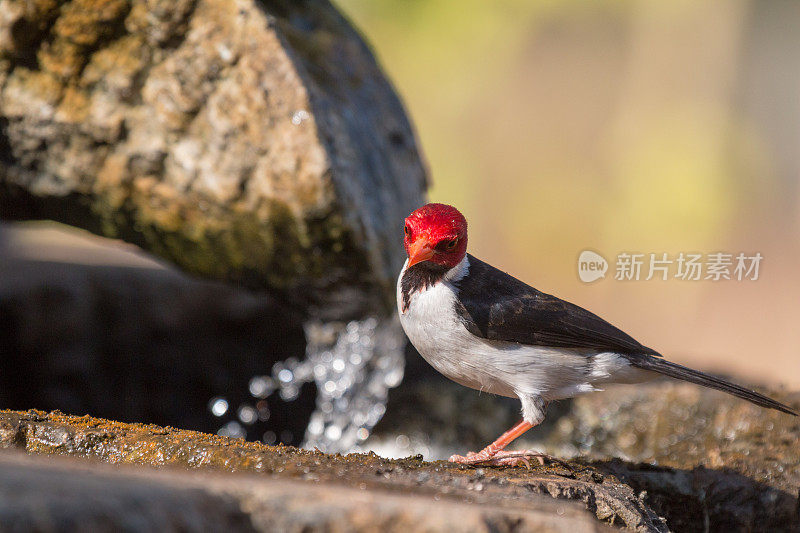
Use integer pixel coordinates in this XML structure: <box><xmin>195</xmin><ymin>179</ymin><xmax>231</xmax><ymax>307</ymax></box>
<box><xmin>455</xmin><ymin>255</ymin><xmax>659</xmax><ymax>355</ymax></box>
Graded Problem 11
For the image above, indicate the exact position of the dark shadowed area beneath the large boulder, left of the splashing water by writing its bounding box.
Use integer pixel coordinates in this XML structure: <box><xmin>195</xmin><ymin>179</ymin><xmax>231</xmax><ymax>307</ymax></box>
<box><xmin>0</xmin><ymin>260</ymin><xmax>316</xmax><ymax>444</ymax></box>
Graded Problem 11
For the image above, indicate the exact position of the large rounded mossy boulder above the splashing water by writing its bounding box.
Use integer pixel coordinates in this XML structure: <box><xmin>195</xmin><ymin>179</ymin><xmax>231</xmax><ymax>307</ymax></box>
<box><xmin>0</xmin><ymin>0</ymin><xmax>425</xmax><ymax>318</ymax></box>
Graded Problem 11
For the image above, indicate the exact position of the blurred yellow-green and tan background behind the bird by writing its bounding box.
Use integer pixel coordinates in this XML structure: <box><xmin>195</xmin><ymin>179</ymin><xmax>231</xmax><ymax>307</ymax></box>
<box><xmin>336</xmin><ymin>0</ymin><xmax>800</xmax><ymax>388</ymax></box>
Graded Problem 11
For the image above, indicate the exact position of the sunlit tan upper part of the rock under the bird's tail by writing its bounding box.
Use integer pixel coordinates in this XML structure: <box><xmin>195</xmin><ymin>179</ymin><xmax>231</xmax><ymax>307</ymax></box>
<box><xmin>542</xmin><ymin>381</ymin><xmax>800</xmax><ymax>489</ymax></box>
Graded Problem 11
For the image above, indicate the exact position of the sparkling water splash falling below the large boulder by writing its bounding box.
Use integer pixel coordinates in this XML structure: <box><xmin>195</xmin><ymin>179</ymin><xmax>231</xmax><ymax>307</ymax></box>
<box><xmin>209</xmin><ymin>318</ymin><xmax>405</xmax><ymax>452</ymax></box>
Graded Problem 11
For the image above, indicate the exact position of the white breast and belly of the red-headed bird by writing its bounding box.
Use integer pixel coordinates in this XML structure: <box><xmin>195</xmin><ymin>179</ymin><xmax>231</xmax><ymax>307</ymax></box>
<box><xmin>397</xmin><ymin>257</ymin><xmax>638</xmax><ymax>401</ymax></box>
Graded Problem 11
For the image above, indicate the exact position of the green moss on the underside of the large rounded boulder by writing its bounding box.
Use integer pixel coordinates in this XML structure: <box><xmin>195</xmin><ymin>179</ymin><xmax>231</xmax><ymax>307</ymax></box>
<box><xmin>86</xmin><ymin>178</ymin><xmax>374</xmax><ymax>308</ymax></box>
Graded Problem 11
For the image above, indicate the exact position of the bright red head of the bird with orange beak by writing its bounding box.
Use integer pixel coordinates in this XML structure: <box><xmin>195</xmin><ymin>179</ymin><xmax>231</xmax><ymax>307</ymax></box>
<box><xmin>403</xmin><ymin>204</ymin><xmax>467</xmax><ymax>269</ymax></box>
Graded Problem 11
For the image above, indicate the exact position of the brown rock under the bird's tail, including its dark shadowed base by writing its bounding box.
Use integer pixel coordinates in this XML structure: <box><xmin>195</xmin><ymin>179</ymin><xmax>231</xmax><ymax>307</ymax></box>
<box><xmin>540</xmin><ymin>382</ymin><xmax>800</xmax><ymax>531</ymax></box>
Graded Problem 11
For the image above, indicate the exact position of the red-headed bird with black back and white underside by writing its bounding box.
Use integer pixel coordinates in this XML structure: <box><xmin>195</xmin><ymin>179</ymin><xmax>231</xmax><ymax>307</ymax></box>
<box><xmin>397</xmin><ymin>203</ymin><xmax>798</xmax><ymax>465</ymax></box>
